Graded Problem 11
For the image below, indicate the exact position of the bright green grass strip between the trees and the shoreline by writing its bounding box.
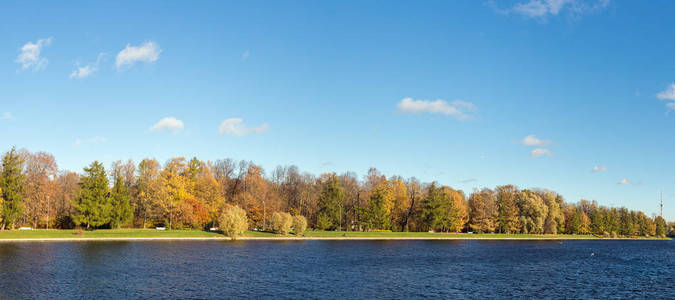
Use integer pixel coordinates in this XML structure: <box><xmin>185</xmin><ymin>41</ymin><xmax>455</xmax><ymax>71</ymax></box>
<box><xmin>0</xmin><ymin>229</ymin><xmax>668</xmax><ymax>240</ymax></box>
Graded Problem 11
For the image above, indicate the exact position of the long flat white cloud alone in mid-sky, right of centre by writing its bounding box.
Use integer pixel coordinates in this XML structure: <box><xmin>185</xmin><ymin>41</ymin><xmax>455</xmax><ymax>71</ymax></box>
<box><xmin>396</xmin><ymin>98</ymin><xmax>476</xmax><ymax>120</ymax></box>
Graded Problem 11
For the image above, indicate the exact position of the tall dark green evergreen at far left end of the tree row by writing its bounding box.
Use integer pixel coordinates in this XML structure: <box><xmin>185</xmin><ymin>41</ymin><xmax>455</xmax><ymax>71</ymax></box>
<box><xmin>0</xmin><ymin>147</ymin><xmax>26</xmax><ymax>229</ymax></box>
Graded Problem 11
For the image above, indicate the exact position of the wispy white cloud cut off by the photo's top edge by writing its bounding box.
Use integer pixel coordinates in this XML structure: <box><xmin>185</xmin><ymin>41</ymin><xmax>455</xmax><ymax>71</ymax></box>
<box><xmin>502</xmin><ymin>0</ymin><xmax>611</xmax><ymax>20</ymax></box>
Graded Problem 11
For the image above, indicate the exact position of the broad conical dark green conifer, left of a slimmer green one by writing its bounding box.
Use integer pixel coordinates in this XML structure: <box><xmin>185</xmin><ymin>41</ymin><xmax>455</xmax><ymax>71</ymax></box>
<box><xmin>73</xmin><ymin>161</ymin><xmax>111</xmax><ymax>229</ymax></box>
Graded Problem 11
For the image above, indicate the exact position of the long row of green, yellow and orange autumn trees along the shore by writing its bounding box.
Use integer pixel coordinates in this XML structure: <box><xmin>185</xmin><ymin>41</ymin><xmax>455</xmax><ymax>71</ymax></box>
<box><xmin>0</xmin><ymin>148</ymin><xmax>668</xmax><ymax>236</ymax></box>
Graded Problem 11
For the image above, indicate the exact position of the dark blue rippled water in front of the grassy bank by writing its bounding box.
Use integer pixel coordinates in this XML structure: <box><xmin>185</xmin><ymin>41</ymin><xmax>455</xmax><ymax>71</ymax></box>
<box><xmin>0</xmin><ymin>240</ymin><xmax>675</xmax><ymax>299</ymax></box>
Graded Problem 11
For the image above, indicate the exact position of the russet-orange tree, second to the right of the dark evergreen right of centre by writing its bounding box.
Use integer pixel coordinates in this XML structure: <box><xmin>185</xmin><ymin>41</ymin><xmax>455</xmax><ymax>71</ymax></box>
<box><xmin>469</xmin><ymin>188</ymin><xmax>499</xmax><ymax>233</ymax></box>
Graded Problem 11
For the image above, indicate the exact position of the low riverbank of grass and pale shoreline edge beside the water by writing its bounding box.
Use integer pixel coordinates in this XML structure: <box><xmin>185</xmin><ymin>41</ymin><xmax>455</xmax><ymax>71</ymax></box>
<box><xmin>0</xmin><ymin>229</ymin><xmax>658</xmax><ymax>242</ymax></box>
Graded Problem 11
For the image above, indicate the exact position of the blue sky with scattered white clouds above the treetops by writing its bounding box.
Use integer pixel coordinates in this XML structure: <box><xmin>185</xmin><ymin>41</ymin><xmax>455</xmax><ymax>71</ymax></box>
<box><xmin>0</xmin><ymin>0</ymin><xmax>675</xmax><ymax>220</ymax></box>
